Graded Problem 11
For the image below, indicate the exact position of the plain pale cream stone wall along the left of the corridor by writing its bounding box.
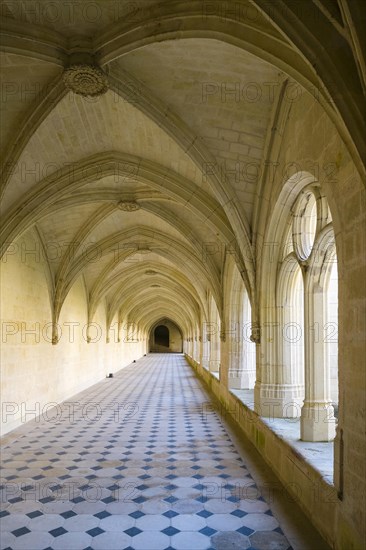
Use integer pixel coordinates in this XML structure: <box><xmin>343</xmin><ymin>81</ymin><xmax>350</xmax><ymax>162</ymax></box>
<box><xmin>0</xmin><ymin>235</ymin><xmax>144</xmax><ymax>434</ymax></box>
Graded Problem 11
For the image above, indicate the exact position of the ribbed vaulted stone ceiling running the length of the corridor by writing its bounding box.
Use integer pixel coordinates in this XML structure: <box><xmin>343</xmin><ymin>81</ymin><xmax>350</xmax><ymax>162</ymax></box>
<box><xmin>1</xmin><ymin>0</ymin><xmax>365</xmax><ymax>338</ymax></box>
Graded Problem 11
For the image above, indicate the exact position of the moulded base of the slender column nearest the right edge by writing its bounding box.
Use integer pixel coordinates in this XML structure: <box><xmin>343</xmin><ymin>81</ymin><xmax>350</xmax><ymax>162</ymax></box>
<box><xmin>300</xmin><ymin>402</ymin><xmax>337</xmax><ymax>442</ymax></box>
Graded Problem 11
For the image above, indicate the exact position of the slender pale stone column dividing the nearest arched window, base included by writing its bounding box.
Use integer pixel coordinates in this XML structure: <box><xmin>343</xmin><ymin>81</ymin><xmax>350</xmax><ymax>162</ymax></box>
<box><xmin>301</xmin><ymin>224</ymin><xmax>338</xmax><ymax>441</ymax></box>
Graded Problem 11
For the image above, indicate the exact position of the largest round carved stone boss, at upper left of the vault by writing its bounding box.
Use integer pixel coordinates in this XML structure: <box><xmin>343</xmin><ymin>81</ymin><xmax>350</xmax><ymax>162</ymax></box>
<box><xmin>62</xmin><ymin>63</ymin><xmax>108</xmax><ymax>97</ymax></box>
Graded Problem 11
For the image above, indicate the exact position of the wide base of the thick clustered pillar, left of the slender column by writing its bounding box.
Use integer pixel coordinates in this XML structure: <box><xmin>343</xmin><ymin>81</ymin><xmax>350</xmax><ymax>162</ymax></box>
<box><xmin>254</xmin><ymin>384</ymin><xmax>304</xmax><ymax>418</ymax></box>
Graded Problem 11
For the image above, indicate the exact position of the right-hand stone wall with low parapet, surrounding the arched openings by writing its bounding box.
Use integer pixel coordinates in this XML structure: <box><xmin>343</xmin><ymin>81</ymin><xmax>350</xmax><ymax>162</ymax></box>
<box><xmin>186</xmin><ymin>91</ymin><xmax>366</xmax><ymax>550</ymax></box>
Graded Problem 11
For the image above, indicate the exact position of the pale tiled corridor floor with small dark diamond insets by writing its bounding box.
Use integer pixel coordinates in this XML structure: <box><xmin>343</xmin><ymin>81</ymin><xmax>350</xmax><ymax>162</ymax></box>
<box><xmin>0</xmin><ymin>354</ymin><xmax>327</xmax><ymax>550</ymax></box>
